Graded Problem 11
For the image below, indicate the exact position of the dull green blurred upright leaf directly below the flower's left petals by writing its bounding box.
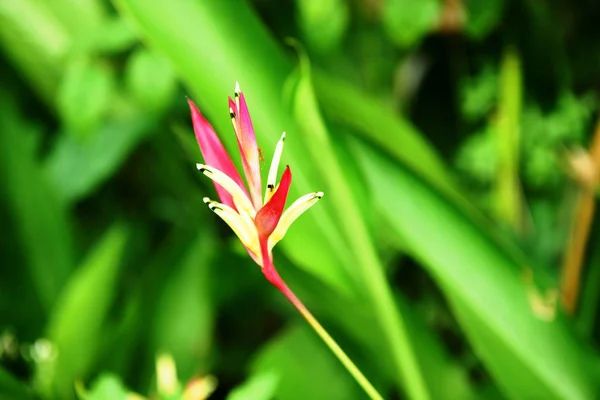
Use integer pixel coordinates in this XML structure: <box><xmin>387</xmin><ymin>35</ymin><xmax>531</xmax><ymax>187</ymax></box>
<box><xmin>152</xmin><ymin>228</ymin><xmax>215</xmax><ymax>381</ymax></box>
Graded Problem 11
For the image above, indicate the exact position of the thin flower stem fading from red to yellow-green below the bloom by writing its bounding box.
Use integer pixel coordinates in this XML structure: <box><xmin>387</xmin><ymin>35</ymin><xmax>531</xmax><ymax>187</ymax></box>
<box><xmin>275</xmin><ymin>280</ymin><xmax>383</xmax><ymax>400</ymax></box>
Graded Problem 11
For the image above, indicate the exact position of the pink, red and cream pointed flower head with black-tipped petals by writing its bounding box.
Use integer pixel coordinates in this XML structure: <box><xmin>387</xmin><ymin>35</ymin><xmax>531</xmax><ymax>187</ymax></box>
<box><xmin>188</xmin><ymin>83</ymin><xmax>323</xmax><ymax>288</ymax></box>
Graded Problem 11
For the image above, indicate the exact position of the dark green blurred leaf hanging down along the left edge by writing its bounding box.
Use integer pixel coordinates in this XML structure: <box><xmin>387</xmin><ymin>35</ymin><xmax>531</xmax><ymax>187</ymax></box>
<box><xmin>0</xmin><ymin>92</ymin><xmax>73</xmax><ymax>310</ymax></box>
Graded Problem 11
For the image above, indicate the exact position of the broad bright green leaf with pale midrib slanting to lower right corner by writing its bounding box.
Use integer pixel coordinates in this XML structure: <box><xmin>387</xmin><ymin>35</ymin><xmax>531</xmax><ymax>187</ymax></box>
<box><xmin>356</xmin><ymin>142</ymin><xmax>598</xmax><ymax>399</ymax></box>
